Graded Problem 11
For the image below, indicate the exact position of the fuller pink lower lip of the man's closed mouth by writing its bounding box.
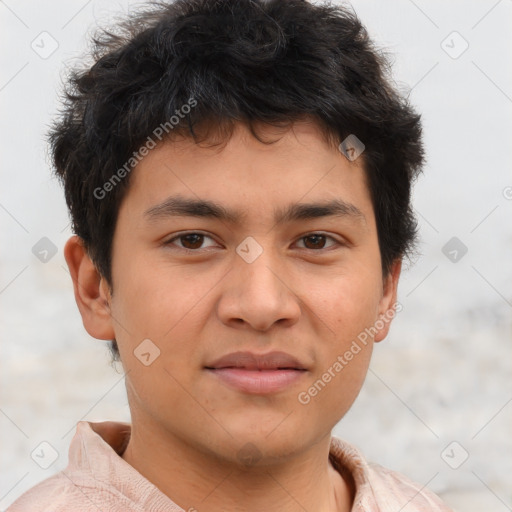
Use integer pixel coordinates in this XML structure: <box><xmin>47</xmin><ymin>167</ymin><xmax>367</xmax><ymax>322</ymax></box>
<box><xmin>208</xmin><ymin>368</ymin><xmax>306</xmax><ymax>395</ymax></box>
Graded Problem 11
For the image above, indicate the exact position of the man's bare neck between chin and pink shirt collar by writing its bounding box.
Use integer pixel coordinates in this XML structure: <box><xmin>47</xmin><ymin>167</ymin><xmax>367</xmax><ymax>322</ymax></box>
<box><xmin>122</xmin><ymin>423</ymin><xmax>352</xmax><ymax>512</ymax></box>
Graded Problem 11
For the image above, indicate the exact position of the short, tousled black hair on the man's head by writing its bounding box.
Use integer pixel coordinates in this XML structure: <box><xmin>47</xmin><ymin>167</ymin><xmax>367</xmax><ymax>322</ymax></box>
<box><xmin>49</xmin><ymin>0</ymin><xmax>423</xmax><ymax>360</ymax></box>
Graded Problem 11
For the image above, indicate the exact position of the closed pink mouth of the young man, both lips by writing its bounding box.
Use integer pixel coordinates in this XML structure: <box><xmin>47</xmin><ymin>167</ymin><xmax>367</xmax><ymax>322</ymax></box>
<box><xmin>205</xmin><ymin>352</ymin><xmax>308</xmax><ymax>395</ymax></box>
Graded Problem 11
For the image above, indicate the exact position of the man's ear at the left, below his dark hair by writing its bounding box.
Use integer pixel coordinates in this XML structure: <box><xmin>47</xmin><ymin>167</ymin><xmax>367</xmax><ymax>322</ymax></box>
<box><xmin>64</xmin><ymin>235</ymin><xmax>115</xmax><ymax>340</ymax></box>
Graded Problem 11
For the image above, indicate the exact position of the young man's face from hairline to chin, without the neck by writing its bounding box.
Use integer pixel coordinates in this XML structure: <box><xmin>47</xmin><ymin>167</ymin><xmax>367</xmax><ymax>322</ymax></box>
<box><xmin>106</xmin><ymin>123</ymin><xmax>396</xmax><ymax>462</ymax></box>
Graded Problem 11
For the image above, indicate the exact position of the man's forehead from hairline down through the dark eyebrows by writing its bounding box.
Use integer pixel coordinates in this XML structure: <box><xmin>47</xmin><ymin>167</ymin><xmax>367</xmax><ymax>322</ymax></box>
<box><xmin>120</xmin><ymin>123</ymin><xmax>371</xmax><ymax>222</ymax></box>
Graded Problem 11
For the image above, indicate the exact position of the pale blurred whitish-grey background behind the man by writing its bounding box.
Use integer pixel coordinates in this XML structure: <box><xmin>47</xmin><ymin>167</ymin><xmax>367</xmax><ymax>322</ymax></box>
<box><xmin>0</xmin><ymin>0</ymin><xmax>512</xmax><ymax>512</ymax></box>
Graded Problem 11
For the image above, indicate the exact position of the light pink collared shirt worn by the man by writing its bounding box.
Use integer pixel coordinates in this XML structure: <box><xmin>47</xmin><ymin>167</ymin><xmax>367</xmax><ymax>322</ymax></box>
<box><xmin>7</xmin><ymin>421</ymin><xmax>452</xmax><ymax>512</ymax></box>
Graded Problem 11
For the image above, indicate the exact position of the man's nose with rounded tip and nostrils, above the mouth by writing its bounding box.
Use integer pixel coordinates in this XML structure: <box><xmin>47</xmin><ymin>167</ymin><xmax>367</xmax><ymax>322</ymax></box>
<box><xmin>218</xmin><ymin>244</ymin><xmax>301</xmax><ymax>331</ymax></box>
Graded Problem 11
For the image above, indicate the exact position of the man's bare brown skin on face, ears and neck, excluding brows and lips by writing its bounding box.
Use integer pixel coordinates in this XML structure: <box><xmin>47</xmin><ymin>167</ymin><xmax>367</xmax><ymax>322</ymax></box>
<box><xmin>65</xmin><ymin>122</ymin><xmax>401</xmax><ymax>512</ymax></box>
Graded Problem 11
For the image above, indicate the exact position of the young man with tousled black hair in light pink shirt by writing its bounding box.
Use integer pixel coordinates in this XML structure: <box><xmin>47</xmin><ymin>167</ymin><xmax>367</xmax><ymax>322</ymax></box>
<box><xmin>9</xmin><ymin>0</ymin><xmax>449</xmax><ymax>512</ymax></box>
